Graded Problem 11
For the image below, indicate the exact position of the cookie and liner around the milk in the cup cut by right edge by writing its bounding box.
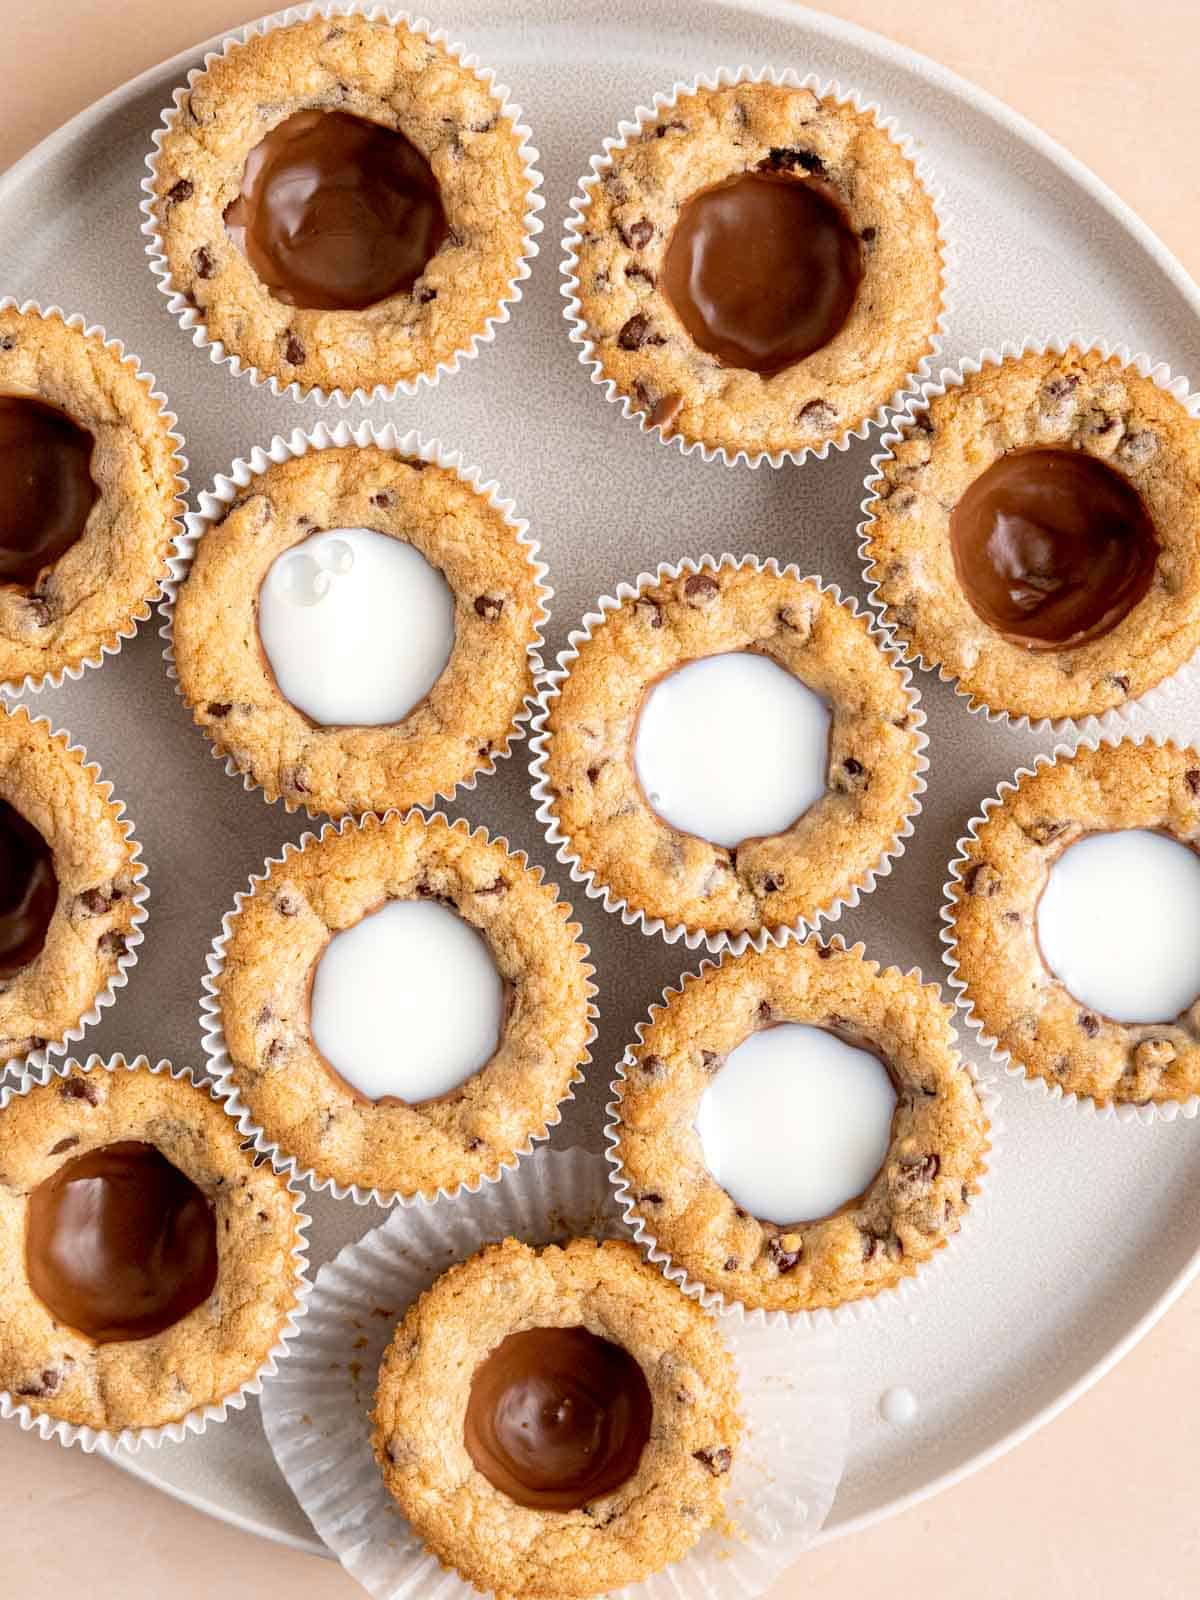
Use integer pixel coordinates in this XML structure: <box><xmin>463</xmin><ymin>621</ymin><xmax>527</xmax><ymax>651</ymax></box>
<box><xmin>941</xmin><ymin>734</ymin><xmax>1200</xmax><ymax>1125</ymax></box>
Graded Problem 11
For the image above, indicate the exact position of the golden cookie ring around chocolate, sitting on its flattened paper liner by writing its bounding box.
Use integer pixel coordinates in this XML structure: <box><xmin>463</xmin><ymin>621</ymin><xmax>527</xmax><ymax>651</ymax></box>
<box><xmin>374</xmin><ymin>1238</ymin><xmax>741</xmax><ymax>1600</ymax></box>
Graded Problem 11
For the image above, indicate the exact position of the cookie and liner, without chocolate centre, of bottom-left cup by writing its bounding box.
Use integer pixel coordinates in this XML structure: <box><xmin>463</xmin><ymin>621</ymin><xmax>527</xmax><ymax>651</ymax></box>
<box><xmin>0</xmin><ymin>1056</ymin><xmax>310</xmax><ymax>1451</ymax></box>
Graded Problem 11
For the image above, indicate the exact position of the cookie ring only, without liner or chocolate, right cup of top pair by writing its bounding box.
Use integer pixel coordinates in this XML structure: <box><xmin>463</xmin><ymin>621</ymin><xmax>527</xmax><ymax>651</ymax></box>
<box><xmin>568</xmin><ymin>82</ymin><xmax>942</xmax><ymax>456</ymax></box>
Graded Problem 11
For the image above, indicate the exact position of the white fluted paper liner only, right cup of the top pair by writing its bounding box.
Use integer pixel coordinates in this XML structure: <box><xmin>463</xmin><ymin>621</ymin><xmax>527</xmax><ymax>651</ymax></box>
<box><xmin>558</xmin><ymin>66</ymin><xmax>957</xmax><ymax>467</ymax></box>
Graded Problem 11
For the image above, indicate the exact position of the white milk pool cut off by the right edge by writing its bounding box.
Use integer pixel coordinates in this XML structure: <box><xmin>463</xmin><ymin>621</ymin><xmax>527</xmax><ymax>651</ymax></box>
<box><xmin>1037</xmin><ymin>827</ymin><xmax>1200</xmax><ymax>1022</ymax></box>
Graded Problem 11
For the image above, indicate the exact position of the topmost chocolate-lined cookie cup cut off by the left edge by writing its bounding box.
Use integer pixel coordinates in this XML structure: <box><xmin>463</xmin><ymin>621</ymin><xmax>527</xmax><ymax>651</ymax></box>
<box><xmin>0</xmin><ymin>299</ymin><xmax>187</xmax><ymax>694</ymax></box>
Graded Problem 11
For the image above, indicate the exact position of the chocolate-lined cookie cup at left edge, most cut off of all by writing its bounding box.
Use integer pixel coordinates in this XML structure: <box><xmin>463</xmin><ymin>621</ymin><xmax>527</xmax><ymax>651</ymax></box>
<box><xmin>0</xmin><ymin>706</ymin><xmax>149</xmax><ymax>1077</ymax></box>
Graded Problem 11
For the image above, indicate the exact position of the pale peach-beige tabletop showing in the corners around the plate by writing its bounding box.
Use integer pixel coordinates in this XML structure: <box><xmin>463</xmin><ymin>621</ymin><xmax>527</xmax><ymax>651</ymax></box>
<box><xmin>0</xmin><ymin>0</ymin><xmax>1200</xmax><ymax>1600</ymax></box>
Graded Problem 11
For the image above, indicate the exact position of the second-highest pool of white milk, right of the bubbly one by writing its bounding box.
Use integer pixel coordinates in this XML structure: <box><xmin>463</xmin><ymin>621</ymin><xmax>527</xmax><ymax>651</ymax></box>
<box><xmin>634</xmin><ymin>650</ymin><xmax>829</xmax><ymax>848</ymax></box>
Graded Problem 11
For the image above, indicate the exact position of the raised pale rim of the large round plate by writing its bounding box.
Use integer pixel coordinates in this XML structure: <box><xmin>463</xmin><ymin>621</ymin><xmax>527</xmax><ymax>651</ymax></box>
<box><xmin>9</xmin><ymin>0</ymin><xmax>1200</xmax><ymax>1560</ymax></box>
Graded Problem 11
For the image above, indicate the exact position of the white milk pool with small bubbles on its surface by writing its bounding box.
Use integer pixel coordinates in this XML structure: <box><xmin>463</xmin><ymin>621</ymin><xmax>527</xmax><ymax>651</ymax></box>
<box><xmin>258</xmin><ymin>528</ymin><xmax>454</xmax><ymax>726</ymax></box>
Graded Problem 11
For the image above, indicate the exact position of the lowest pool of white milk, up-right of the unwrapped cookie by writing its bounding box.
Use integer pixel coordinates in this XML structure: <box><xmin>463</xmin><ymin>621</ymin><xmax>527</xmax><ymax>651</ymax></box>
<box><xmin>696</xmin><ymin>1022</ymin><xmax>896</xmax><ymax>1224</ymax></box>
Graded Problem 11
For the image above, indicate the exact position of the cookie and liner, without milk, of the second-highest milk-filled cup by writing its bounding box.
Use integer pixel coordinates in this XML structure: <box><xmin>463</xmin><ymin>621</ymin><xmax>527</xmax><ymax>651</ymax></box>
<box><xmin>530</xmin><ymin>555</ymin><xmax>928</xmax><ymax>954</ymax></box>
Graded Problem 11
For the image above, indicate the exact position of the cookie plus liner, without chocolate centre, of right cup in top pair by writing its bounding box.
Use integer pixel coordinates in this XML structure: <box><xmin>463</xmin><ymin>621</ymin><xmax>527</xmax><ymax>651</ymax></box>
<box><xmin>560</xmin><ymin>67</ymin><xmax>954</xmax><ymax>467</ymax></box>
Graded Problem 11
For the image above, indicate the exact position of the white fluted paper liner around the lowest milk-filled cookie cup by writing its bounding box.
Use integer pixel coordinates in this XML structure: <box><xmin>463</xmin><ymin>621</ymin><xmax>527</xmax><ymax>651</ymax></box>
<box><xmin>605</xmin><ymin>931</ymin><xmax>1005</xmax><ymax>1331</ymax></box>
